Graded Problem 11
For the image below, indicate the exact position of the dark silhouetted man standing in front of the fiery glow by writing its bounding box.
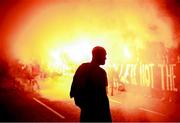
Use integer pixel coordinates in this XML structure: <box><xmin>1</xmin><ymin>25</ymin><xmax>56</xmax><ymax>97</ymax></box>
<box><xmin>70</xmin><ymin>46</ymin><xmax>112</xmax><ymax>122</ymax></box>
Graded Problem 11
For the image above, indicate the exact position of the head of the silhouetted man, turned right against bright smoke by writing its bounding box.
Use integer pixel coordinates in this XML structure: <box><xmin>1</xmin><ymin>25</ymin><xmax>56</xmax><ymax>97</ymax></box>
<box><xmin>92</xmin><ymin>46</ymin><xmax>106</xmax><ymax>65</ymax></box>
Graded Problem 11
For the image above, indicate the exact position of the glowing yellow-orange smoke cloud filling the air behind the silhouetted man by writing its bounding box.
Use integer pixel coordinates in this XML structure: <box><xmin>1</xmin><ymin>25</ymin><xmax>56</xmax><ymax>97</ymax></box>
<box><xmin>1</xmin><ymin>0</ymin><xmax>174</xmax><ymax>99</ymax></box>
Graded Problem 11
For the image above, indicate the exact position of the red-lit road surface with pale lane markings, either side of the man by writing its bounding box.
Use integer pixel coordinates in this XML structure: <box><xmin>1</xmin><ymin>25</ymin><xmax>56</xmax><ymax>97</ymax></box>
<box><xmin>0</xmin><ymin>84</ymin><xmax>180</xmax><ymax>122</ymax></box>
